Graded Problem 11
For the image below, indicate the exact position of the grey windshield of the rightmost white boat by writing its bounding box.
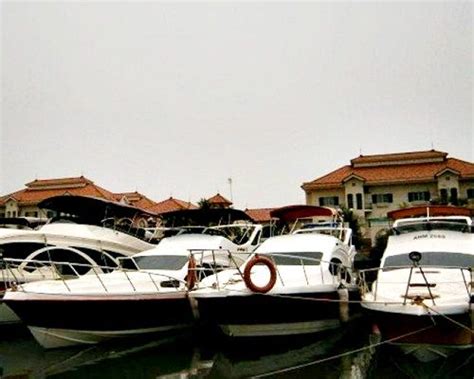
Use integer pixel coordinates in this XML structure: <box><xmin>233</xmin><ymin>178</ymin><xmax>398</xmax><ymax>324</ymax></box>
<box><xmin>383</xmin><ymin>251</ymin><xmax>474</xmax><ymax>269</ymax></box>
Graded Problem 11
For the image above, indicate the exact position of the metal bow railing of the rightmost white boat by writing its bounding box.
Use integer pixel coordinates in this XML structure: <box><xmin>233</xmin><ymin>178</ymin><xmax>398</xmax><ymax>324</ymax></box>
<box><xmin>357</xmin><ymin>264</ymin><xmax>474</xmax><ymax>305</ymax></box>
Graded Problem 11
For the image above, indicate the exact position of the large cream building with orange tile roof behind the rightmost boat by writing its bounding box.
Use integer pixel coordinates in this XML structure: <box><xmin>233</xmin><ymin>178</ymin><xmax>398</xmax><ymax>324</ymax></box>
<box><xmin>301</xmin><ymin>150</ymin><xmax>474</xmax><ymax>242</ymax></box>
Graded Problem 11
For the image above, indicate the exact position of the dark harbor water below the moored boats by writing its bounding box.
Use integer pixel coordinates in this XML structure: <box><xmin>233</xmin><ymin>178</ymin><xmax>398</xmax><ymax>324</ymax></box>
<box><xmin>0</xmin><ymin>322</ymin><xmax>474</xmax><ymax>379</ymax></box>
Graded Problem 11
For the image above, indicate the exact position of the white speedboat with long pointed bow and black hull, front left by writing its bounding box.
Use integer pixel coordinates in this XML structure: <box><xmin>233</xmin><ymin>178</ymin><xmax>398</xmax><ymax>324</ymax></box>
<box><xmin>4</xmin><ymin>226</ymin><xmax>261</xmax><ymax>348</ymax></box>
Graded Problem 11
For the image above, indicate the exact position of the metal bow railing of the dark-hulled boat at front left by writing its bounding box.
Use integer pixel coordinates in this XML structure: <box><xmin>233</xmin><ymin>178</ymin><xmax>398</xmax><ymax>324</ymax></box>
<box><xmin>0</xmin><ymin>258</ymin><xmax>186</xmax><ymax>293</ymax></box>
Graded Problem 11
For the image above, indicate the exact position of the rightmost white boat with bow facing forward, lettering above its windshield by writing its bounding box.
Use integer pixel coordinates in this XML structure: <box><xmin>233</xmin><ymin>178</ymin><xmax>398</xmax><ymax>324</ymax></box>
<box><xmin>362</xmin><ymin>212</ymin><xmax>474</xmax><ymax>360</ymax></box>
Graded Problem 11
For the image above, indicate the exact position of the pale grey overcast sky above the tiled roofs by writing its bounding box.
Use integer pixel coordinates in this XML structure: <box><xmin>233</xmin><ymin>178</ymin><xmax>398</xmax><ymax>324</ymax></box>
<box><xmin>0</xmin><ymin>1</ymin><xmax>474</xmax><ymax>208</ymax></box>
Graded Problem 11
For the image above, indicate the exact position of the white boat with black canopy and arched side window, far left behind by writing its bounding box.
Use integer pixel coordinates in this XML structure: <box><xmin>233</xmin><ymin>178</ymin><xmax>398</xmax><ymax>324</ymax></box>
<box><xmin>0</xmin><ymin>195</ymin><xmax>156</xmax><ymax>279</ymax></box>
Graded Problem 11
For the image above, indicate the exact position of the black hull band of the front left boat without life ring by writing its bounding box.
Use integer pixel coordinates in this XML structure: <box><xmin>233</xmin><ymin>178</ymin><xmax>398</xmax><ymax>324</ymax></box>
<box><xmin>5</xmin><ymin>296</ymin><xmax>194</xmax><ymax>331</ymax></box>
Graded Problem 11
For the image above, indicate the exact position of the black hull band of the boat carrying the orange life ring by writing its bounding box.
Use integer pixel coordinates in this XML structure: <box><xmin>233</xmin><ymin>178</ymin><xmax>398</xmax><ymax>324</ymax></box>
<box><xmin>197</xmin><ymin>292</ymin><xmax>358</xmax><ymax>325</ymax></box>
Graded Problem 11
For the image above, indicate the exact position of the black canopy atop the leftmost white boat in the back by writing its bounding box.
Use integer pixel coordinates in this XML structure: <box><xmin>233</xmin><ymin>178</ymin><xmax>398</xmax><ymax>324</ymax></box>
<box><xmin>38</xmin><ymin>195</ymin><xmax>158</xmax><ymax>225</ymax></box>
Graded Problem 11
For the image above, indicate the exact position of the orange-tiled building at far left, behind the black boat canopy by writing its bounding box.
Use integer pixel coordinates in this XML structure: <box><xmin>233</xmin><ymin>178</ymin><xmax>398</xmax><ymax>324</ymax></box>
<box><xmin>0</xmin><ymin>176</ymin><xmax>116</xmax><ymax>218</ymax></box>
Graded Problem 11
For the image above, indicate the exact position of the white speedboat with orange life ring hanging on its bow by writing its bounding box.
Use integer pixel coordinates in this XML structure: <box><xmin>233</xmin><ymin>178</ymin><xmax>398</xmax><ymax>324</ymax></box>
<box><xmin>190</xmin><ymin>226</ymin><xmax>358</xmax><ymax>337</ymax></box>
